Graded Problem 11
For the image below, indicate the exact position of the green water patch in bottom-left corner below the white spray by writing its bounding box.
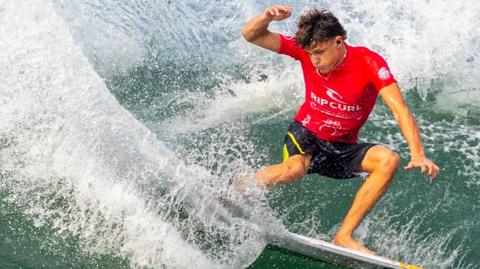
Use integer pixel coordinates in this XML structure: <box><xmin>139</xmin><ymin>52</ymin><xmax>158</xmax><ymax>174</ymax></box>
<box><xmin>0</xmin><ymin>192</ymin><xmax>130</xmax><ymax>269</ymax></box>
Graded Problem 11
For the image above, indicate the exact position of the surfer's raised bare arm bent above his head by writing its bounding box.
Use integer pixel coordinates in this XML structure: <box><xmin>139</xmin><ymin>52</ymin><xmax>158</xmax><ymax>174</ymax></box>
<box><xmin>242</xmin><ymin>6</ymin><xmax>292</xmax><ymax>52</ymax></box>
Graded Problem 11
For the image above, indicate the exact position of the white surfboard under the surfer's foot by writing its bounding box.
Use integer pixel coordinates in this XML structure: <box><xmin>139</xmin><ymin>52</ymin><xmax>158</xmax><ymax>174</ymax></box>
<box><xmin>268</xmin><ymin>231</ymin><xmax>422</xmax><ymax>269</ymax></box>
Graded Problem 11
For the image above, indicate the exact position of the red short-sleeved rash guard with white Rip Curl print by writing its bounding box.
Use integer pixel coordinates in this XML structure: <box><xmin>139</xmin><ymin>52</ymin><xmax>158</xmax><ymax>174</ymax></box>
<box><xmin>278</xmin><ymin>35</ymin><xmax>396</xmax><ymax>143</ymax></box>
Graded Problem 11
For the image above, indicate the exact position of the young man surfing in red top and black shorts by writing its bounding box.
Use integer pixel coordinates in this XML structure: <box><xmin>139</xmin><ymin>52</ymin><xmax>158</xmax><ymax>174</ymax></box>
<box><xmin>242</xmin><ymin>5</ymin><xmax>439</xmax><ymax>254</ymax></box>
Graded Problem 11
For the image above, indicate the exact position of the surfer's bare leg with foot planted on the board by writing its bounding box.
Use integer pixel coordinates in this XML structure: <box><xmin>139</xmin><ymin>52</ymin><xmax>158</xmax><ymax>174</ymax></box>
<box><xmin>333</xmin><ymin>145</ymin><xmax>400</xmax><ymax>254</ymax></box>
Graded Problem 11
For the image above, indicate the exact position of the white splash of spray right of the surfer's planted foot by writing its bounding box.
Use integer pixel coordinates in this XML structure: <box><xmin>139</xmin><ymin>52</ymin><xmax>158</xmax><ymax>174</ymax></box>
<box><xmin>355</xmin><ymin>208</ymin><xmax>471</xmax><ymax>268</ymax></box>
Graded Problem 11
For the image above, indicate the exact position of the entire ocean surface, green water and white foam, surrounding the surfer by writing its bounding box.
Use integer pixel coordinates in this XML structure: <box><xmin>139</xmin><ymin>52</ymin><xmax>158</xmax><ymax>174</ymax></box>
<box><xmin>0</xmin><ymin>0</ymin><xmax>480</xmax><ymax>268</ymax></box>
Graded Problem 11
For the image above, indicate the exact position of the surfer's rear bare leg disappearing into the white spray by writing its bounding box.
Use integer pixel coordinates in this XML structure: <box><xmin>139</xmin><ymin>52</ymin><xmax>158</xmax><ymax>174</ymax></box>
<box><xmin>255</xmin><ymin>154</ymin><xmax>310</xmax><ymax>188</ymax></box>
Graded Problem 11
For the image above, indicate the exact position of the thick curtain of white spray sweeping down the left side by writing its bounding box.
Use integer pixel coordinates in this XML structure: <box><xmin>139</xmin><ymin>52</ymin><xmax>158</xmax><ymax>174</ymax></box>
<box><xmin>0</xmin><ymin>1</ymin><xmax>268</xmax><ymax>268</ymax></box>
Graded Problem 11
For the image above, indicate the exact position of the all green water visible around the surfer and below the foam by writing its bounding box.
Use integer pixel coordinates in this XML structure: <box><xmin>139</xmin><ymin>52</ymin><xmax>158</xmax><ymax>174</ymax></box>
<box><xmin>0</xmin><ymin>57</ymin><xmax>480</xmax><ymax>268</ymax></box>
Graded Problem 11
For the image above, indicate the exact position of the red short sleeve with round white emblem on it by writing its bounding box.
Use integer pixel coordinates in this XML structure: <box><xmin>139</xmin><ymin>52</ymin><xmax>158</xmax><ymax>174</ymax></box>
<box><xmin>366</xmin><ymin>51</ymin><xmax>397</xmax><ymax>91</ymax></box>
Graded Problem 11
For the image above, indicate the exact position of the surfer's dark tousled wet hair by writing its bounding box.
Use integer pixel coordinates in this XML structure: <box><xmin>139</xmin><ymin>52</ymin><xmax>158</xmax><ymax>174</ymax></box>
<box><xmin>295</xmin><ymin>8</ymin><xmax>347</xmax><ymax>48</ymax></box>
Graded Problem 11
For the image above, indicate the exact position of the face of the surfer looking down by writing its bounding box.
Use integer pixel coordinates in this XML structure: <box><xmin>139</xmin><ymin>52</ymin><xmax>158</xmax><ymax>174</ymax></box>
<box><xmin>305</xmin><ymin>37</ymin><xmax>344</xmax><ymax>74</ymax></box>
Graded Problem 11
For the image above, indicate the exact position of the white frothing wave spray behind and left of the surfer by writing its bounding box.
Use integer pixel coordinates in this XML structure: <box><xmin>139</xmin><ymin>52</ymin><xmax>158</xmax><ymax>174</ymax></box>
<box><xmin>0</xmin><ymin>0</ymin><xmax>480</xmax><ymax>268</ymax></box>
